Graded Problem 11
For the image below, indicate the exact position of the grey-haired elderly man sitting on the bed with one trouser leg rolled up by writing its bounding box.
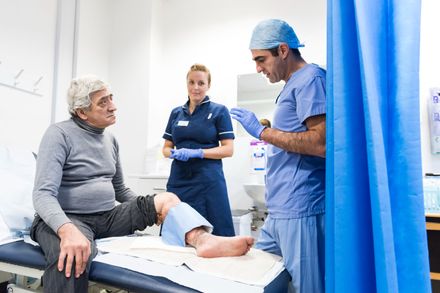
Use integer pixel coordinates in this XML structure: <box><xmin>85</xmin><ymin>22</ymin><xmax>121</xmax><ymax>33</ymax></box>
<box><xmin>31</xmin><ymin>76</ymin><xmax>253</xmax><ymax>292</ymax></box>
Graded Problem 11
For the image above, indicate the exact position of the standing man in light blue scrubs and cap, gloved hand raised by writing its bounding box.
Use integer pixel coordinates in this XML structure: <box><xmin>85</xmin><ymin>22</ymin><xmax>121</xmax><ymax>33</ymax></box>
<box><xmin>230</xmin><ymin>19</ymin><xmax>326</xmax><ymax>293</ymax></box>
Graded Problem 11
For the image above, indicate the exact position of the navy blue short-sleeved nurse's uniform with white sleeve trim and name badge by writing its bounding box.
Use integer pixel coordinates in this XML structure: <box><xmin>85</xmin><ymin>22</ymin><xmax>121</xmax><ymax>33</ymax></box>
<box><xmin>163</xmin><ymin>96</ymin><xmax>235</xmax><ymax>236</ymax></box>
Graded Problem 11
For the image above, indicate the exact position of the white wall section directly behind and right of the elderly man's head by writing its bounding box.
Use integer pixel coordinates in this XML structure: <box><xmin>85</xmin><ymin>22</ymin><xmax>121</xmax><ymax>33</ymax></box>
<box><xmin>77</xmin><ymin>0</ymin><xmax>156</xmax><ymax>174</ymax></box>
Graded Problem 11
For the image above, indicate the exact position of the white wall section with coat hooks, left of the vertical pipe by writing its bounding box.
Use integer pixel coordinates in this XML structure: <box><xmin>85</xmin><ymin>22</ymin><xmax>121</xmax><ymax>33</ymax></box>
<box><xmin>0</xmin><ymin>0</ymin><xmax>57</xmax><ymax>151</ymax></box>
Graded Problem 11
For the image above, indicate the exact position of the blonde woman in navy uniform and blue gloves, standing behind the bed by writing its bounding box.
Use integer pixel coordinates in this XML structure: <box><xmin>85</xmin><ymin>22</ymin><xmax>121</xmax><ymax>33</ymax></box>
<box><xmin>162</xmin><ymin>64</ymin><xmax>235</xmax><ymax>236</ymax></box>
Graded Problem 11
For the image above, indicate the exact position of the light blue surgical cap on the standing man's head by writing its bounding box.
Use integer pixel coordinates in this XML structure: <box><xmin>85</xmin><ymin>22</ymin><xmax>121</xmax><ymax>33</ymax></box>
<box><xmin>249</xmin><ymin>19</ymin><xmax>304</xmax><ymax>49</ymax></box>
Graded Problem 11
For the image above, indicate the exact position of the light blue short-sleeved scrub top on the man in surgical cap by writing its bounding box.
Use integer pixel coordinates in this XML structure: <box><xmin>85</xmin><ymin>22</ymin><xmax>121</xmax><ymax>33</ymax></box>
<box><xmin>266</xmin><ymin>64</ymin><xmax>326</xmax><ymax>218</ymax></box>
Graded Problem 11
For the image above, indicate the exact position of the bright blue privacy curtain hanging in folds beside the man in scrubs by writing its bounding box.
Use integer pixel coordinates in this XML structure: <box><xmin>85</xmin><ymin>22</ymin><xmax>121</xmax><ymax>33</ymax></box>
<box><xmin>326</xmin><ymin>0</ymin><xmax>431</xmax><ymax>293</ymax></box>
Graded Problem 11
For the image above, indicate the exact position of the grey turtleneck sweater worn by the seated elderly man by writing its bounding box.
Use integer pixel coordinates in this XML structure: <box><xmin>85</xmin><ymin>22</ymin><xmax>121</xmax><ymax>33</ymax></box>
<box><xmin>33</xmin><ymin>117</ymin><xmax>136</xmax><ymax>233</ymax></box>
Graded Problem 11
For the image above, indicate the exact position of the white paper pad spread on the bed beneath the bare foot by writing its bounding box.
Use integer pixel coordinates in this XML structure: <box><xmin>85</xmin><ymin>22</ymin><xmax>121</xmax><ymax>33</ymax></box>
<box><xmin>95</xmin><ymin>236</ymin><xmax>284</xmax><ymax>292</ymax></box>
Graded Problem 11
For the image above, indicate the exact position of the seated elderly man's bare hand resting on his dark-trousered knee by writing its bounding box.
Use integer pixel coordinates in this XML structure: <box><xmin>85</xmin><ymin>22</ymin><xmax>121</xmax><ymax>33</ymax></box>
<box><xmin>58</xmin><ymin>223</ymin><xmax>91</xmax><ymax>278</ymax></box>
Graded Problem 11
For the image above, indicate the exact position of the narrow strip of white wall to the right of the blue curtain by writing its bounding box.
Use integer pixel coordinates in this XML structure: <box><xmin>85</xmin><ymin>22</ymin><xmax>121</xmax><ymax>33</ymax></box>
<box><xmin>420</xmin><ymin>0</ymin><xmax>440</xmax><ymax>173</ymax></box>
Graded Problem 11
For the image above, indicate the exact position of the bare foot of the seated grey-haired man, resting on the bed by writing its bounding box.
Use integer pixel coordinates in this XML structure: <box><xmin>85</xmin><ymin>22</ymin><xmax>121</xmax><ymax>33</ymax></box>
<box><xmin>187</xmin><ymin>230</ymin><xmax>254</xmax><ymax>258</ymax></box>
